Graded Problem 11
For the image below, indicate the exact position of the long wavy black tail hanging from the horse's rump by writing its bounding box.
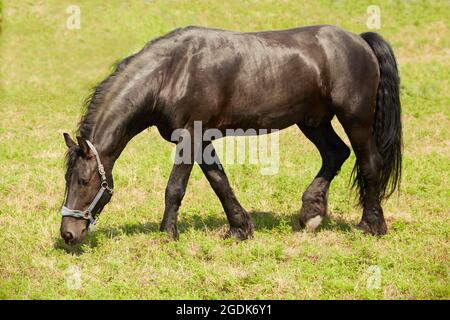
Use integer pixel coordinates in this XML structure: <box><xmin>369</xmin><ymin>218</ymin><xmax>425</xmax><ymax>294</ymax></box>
<box><xmin>354</xmin><ymin>32</ymin><xmax>402</xmax><ymax>200</ymax></box>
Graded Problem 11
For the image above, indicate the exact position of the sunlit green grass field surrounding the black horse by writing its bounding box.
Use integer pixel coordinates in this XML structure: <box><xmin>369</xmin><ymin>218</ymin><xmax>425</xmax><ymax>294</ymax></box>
<box><xmin>0</xmin><ymin>0</ymin><xmax>450</xmax><ymax>299</ymax></box>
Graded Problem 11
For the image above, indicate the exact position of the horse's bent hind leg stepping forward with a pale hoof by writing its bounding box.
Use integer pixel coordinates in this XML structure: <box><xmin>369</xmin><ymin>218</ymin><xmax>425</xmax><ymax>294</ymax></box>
<box><xmin>298</xmin><ymin>121</ymin><xmax>350</xmax><ymax>231</ymax></box>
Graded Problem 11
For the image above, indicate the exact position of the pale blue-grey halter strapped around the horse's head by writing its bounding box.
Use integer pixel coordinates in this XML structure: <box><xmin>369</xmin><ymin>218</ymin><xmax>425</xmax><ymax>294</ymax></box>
<box><xmin>61</xmin><ymin>140</ymin><xmax>113</xmax><ymax>231</ymax></box>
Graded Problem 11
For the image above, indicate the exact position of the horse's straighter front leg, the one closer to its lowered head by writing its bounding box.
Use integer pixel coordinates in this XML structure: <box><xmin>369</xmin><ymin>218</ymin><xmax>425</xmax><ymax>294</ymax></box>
<box><xmin>160</xmin><ymin>163</ymin><xmax>193</xmax><ymax>240</ymax></box>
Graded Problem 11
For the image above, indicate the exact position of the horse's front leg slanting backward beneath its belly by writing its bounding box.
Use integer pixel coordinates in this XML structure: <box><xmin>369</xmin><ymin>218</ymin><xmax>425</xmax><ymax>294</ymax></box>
<box><xmin>200</xmin><ymin>143</ymin><xmax>253</xmax><ymax>240</ymax></box>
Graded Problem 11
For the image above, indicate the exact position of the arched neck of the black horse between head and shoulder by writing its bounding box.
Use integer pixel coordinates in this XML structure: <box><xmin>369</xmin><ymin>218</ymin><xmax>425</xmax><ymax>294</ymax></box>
<box><xmin>83</xmin><ymin>52</ymin><xmax>161</xmax><ymax>165</ymax></box>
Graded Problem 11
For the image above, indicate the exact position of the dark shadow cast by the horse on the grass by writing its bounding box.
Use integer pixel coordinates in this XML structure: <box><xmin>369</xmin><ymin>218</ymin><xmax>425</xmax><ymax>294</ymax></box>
<box><xmin>53</xmin><ymin>211</ymin><xmax>353</xmax><ymax>255</ymax></box>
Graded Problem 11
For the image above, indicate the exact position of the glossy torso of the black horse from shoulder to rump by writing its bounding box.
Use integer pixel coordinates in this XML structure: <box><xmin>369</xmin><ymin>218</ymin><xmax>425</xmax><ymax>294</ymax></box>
<box><xmin>152</xmin><ymin>25</ymin><xmax>375</xmax><ymax>128</ymax></box>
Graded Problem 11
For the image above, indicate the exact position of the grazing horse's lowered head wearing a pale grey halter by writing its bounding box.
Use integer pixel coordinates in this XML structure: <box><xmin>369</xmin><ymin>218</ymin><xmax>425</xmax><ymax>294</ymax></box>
<box><xmin>60</xmin><ymin>133</ymin><xmax>112</xmax><ymax>244</ymax></box>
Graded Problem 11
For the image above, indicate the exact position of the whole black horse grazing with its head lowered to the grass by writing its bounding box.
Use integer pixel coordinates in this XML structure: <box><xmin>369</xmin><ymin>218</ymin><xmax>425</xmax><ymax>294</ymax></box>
<box><xmin>61</xmin><ymin>25</ymin><xmax>402</xmax><ymax>243</ymax></box>
